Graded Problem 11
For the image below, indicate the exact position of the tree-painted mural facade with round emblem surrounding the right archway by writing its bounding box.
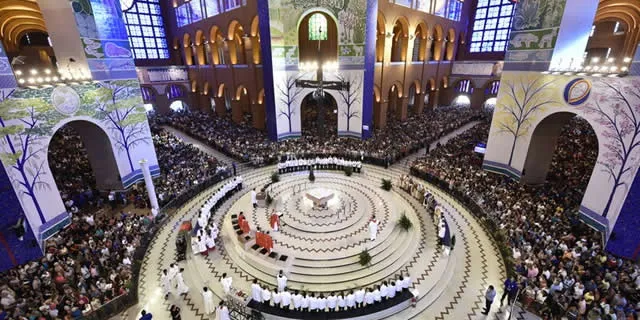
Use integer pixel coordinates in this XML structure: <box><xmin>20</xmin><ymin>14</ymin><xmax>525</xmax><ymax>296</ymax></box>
<box><xmin>484</xmin><ymin>71</ymin><xmax>640</xmax><ymax>248</ymax></box>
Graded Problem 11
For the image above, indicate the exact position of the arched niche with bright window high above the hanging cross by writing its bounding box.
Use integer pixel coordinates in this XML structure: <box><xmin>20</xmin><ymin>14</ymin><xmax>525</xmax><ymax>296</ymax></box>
<box><xmin>298</xmin><ymin>10</ymin><xmax>338</xmax><ymax>62</ymax></box>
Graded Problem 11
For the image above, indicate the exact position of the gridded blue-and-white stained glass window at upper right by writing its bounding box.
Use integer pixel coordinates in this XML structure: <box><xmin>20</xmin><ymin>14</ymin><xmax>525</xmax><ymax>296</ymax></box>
<box><xmin>469</xmin><ymin>0</ymin><xmax>514</xmax><ymax>53</ymax></box>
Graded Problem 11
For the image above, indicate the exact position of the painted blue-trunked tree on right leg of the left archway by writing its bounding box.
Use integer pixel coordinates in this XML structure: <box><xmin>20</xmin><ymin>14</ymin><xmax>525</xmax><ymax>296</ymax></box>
<box><xmin>83</xmin><ymin>80</ymin><xmax>151</xmax><ymax>172</ymax></box>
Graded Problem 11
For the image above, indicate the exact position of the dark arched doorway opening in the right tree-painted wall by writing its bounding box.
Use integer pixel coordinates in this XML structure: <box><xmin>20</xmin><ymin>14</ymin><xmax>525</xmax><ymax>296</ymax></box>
<box><xmin>521</xmin><ymin>112</ymin><xmax>598</xmax><ymax>191</ymax></box>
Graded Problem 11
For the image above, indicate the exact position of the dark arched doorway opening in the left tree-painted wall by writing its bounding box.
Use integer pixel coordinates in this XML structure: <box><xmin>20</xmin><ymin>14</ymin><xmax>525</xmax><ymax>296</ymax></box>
<box><xmin>48</xmin><ymin>120</ymin><xmax>123</xmax><ymax>209</ymax></box>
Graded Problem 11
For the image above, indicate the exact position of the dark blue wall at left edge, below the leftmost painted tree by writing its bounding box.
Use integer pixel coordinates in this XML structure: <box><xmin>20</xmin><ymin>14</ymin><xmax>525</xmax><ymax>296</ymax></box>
<box><xmin>0</xmin><ymin>165</ymin><xmax>42</xmax><ymax>271</ymax></box>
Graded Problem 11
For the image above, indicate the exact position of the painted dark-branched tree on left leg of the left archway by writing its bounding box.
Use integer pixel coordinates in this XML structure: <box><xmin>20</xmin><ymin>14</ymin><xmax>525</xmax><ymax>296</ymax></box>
<box><xmin>0</xmin><ymin>91</ymin><xmax>64</xmax><ymax>223</ymax></box>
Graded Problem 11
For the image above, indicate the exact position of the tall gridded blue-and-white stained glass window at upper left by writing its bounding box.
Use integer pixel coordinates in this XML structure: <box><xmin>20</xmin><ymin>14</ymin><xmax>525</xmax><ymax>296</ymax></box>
<box><xmin>123</xmin><ymin>0</ymin><xmax>169</xmax><ymax>59</ymax></box>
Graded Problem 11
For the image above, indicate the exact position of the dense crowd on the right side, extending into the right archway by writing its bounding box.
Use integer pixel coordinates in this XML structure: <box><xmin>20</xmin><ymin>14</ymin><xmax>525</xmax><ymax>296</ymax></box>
<box><xmin>412</xmin><ymin>117</ymin><xmax>640</xmax><ymax>319</ymax></box>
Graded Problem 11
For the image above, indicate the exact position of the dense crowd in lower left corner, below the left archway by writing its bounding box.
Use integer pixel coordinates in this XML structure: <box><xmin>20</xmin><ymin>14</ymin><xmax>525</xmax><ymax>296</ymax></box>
<box><xmin>0</xmin><ymin>212</ymin><xmax>152</xmax><ymax>319</ymax></box>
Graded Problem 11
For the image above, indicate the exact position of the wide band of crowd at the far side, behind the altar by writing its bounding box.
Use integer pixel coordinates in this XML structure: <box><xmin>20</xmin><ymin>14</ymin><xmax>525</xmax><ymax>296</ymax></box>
<box><xmin>154</xmin><ymin>108</ymin><xmax>484</xmax><ymax>165</ymax></box>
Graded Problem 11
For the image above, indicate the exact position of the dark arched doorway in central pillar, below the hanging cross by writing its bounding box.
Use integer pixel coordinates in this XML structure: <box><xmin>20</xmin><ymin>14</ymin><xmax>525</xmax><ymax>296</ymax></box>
<box><xmin>300</xmin><ymin>92</ymin><xmax>338</xmax><ymax>137</ymax></box>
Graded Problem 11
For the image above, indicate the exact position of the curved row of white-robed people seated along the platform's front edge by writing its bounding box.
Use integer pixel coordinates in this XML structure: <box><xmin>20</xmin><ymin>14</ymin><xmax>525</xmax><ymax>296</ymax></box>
<box><xmin>251</xmin><ymin>270</ymin><xmax>412</xmax><ymax>312</ymax></box>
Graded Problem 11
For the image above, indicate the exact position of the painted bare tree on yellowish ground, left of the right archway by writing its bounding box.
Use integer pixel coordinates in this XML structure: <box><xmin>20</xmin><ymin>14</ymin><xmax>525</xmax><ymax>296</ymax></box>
<box><xmin>496</xmin><ymin>77</ymin><xmax>559</xmax><ymax>166</ymax></box>
